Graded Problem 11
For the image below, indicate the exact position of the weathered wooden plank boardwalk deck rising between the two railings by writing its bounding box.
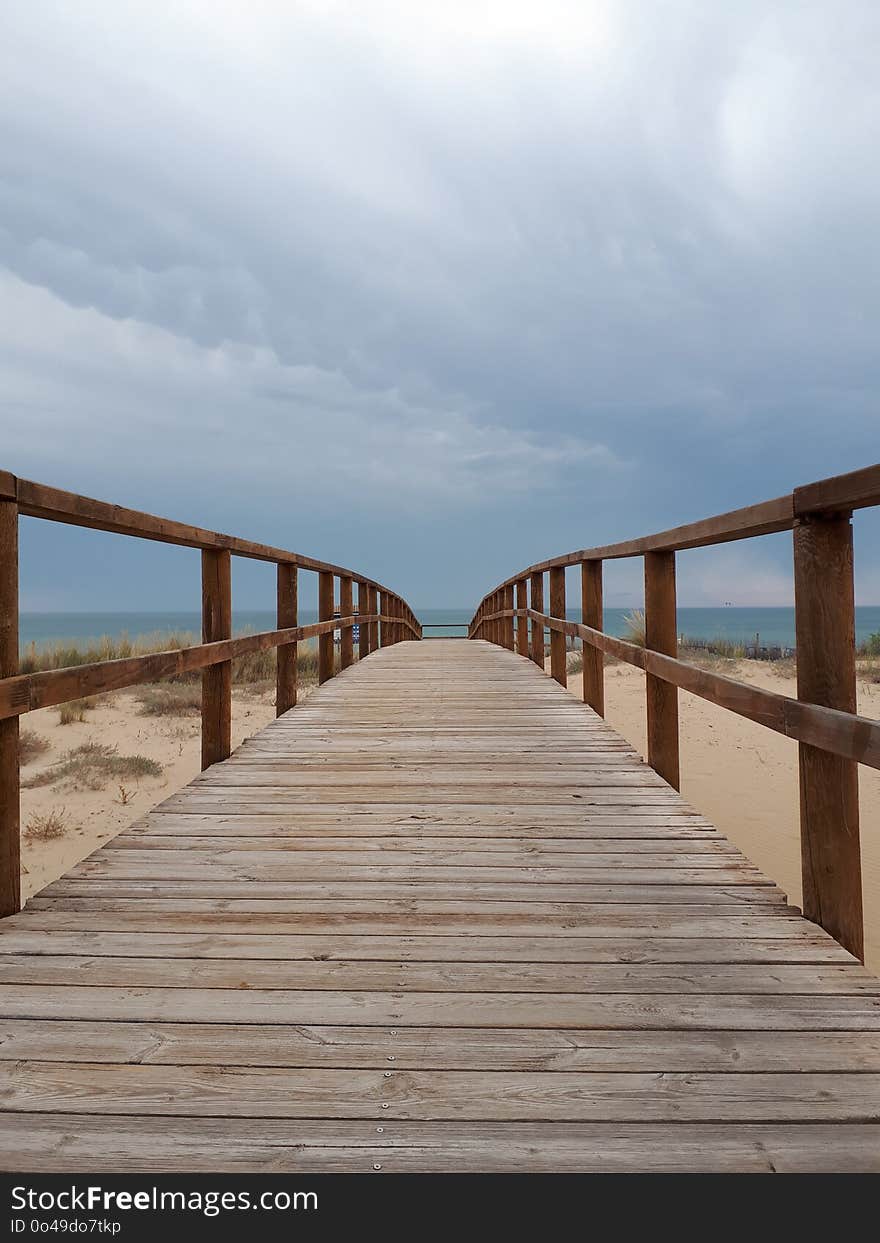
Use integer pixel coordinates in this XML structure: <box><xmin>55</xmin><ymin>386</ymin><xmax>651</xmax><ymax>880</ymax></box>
<box><xmin>0</xmin><ymin>640</ymin><xmax>880</xmax><ymax>1172</ymax></box>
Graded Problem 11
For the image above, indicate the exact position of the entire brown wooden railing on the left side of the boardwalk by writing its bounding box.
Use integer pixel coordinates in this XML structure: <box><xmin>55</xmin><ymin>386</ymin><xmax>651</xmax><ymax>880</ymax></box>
<box><xmin>0</xmin><ymin>471</ymin><xmax>421</xmax><ymax>915</ymax></box>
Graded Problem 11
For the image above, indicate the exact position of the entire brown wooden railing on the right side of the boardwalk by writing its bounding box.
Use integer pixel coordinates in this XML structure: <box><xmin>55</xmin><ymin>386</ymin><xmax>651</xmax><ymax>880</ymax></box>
<box><xmin>469</xmin><ymin>465</ymin><xmax>880</xmax><ymax>958</ymax></box>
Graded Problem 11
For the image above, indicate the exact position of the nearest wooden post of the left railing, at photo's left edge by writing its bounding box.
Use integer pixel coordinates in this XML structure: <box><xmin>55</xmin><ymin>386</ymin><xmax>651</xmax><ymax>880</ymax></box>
<box><xmin>0</xmin><ymin>484</ymin><xmax>21</xmax><ymax>915</ymax></box>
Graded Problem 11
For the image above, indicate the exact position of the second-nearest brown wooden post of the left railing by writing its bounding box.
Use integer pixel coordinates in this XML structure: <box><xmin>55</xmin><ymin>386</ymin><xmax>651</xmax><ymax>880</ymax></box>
<box><xmin>201</xmin><ymin>548</ymin><xmax>232</xmax><ymax>769</ymax></box>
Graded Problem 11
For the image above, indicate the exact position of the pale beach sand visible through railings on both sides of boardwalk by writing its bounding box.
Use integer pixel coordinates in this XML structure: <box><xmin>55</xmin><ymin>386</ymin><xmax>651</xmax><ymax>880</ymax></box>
<box><xmin>15</xmin><ymin>660</ymin><xmax>880</xmax><ymax>970</ymax></box>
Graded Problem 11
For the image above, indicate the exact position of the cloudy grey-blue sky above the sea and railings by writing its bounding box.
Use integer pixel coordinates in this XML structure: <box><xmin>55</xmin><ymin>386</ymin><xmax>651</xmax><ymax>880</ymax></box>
<box><xmin>0</xmin><ymin>0</ymin><xmax>880</xmax><ymax>609</ymax></box>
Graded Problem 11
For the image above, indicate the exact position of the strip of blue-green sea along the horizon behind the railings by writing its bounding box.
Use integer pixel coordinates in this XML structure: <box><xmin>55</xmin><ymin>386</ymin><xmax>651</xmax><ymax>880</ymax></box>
<box><xmin>19</xmin><ymin>604</ymin><xmax>880</xmax><ymax>649</ymax></box>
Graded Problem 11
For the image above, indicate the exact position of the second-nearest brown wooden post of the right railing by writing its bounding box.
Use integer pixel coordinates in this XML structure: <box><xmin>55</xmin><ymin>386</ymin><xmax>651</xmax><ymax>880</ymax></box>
<box><xmin>645</xmin><ymin>552</ymin><xmax>681</xmax><ymax>789</ymax></box>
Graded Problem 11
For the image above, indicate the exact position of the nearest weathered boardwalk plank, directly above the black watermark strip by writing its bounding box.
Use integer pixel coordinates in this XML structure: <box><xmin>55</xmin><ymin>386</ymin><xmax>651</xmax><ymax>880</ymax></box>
<box><xmin>4</xmin><ymin>1114</ymin><xmax>880</xmax><ymax>1176</ymax></box>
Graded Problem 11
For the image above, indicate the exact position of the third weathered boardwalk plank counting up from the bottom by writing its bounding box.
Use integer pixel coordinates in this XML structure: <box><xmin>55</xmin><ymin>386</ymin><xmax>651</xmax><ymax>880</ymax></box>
<box><xmin>0</xmin><ymin>1018</ymin><xmax>880</xmax><ymax>1074</ymax></box>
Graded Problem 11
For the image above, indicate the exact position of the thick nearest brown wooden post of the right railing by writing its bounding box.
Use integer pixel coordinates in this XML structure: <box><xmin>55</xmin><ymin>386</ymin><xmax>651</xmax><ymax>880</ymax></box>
<box><xmin>794</xmin><ymin>513</ymin><xmax>864</xmax><ymax>958</ymax></box>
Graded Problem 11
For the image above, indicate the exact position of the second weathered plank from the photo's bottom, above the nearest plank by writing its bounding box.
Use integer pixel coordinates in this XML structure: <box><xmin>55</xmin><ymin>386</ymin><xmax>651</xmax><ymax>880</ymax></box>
<box><xmin>0</xmin><ymin>1062</ymin><xmax>880</xmax><ymax>1122</ymax></box>
